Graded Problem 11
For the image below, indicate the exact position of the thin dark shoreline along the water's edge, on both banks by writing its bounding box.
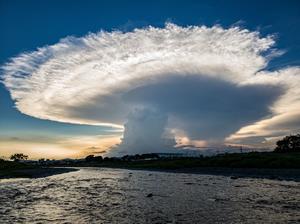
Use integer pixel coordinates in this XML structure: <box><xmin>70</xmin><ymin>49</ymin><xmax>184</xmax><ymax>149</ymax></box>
<box><xmin>0</xmin><ymin>166</ymin><xmax>300</xmax><ymax>182</ymax></box>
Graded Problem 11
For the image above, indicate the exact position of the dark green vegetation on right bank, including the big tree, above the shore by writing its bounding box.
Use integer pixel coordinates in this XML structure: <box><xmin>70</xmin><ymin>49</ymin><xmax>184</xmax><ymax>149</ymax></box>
<box><xmin>81</xmin><ymin>134</ymin><xmax>300</xmax><ymax>169</ymax></box>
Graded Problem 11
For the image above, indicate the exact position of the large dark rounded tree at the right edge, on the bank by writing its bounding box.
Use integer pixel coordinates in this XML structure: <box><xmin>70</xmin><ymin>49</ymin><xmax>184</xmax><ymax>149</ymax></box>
<box><xmin>274</xmin><ymin>134</ymin><xmax>300</xmax><ymax>152</ymax></box>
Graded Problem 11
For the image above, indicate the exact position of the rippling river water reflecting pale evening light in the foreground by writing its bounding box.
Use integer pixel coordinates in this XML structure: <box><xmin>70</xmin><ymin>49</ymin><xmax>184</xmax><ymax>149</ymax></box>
<box><xmin>0</xmin><ymin>168</ymin><xmax>300</xmax><ymax>223</ymax></box>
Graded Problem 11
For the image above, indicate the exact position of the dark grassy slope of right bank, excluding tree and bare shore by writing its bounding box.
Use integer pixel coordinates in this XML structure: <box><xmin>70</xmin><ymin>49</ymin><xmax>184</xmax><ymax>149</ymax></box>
<box><xmin>78</xmin><ymin>152</ymin><xmax>300</xmax><ymax>169</ymax></box>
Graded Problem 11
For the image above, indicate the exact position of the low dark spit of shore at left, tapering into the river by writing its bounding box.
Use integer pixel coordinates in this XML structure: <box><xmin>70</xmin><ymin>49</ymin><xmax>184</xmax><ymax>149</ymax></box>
<box><xmin>0</xmin><ymin>167</ymin><xmax>79</xmax><ymax>179</ymax></box>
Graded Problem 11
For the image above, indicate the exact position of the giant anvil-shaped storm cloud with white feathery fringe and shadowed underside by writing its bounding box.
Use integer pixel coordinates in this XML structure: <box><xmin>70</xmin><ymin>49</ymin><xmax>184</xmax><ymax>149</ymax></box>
<box><xmin>2</xmin><ymin>23</ymin><xmax>300</xmax><ymax>155</ymax></box>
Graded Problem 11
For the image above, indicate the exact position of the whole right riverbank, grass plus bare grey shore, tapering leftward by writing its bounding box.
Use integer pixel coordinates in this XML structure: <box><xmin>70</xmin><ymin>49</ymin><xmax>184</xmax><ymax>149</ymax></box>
<box><xmin>75</xmin><ymin>152</ymin><xmax>300</xmax><ymax>182</ymax></box>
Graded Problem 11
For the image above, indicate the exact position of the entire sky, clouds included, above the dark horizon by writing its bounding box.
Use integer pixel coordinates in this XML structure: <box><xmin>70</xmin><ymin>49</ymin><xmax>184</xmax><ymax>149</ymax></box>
<box><xmin>0</xmin><ymin>1</ymin><xmax>300</xmax><ymax>158</ymax></box>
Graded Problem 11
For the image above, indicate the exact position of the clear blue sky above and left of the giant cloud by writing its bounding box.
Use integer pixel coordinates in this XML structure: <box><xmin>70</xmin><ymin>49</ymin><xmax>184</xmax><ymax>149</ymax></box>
<box><xmin>0</xmin><ymin>0</ymin><xmax>300</xmax><ymax>158</ymax></box>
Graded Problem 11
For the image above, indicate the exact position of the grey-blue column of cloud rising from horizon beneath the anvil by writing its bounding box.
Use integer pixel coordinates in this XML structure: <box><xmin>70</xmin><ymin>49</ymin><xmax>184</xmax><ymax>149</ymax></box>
<box><xmin>109</xmin><ymin>108</ymin><xmax>176</xmax><ymax>156</ymax></box>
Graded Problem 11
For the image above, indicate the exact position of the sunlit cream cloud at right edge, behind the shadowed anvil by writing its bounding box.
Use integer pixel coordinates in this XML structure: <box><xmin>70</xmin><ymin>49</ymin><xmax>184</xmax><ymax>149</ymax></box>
<box><xmin>227</xmin><ymin>67</ymin><xmax>300</xmax><ymax>143</ymax></box>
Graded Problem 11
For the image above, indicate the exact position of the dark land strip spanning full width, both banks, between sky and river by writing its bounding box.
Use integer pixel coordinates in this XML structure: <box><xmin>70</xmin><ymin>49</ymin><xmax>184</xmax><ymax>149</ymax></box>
<box><xmin>0</xmin><ymin>152</ymin><xmax>300</xmax><ymax>181</ymax></box>
